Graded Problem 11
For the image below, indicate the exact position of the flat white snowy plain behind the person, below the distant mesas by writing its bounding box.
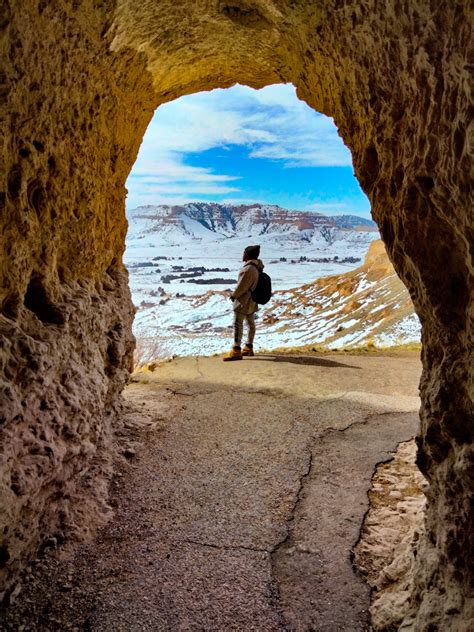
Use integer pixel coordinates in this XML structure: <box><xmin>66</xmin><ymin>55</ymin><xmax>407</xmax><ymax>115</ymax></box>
<box><xmin>125</xmin><ymin>220</ymin><xmax>379</xmax><ymax>359</ymax></box>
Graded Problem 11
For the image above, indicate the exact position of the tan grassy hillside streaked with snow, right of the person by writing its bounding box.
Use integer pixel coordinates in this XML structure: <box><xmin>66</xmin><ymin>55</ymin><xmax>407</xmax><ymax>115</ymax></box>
<box><xmin>263</xmin><ymin>241</ymin><xmax>420</xmax><ymax>349</ymax></box>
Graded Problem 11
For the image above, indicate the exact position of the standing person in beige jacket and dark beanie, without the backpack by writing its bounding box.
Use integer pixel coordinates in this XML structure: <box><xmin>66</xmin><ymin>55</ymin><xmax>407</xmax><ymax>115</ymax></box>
<box><xmin>223</xmin><ymin>246</ymin><xmax>264</xmax><ymax>362</ymax></box>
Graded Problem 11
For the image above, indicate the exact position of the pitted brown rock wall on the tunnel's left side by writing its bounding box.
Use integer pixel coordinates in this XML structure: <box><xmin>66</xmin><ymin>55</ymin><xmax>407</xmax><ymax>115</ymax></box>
<box><xmin>0</xmin><ymin>0</ymin><xmax>154</xmax><ymax>593</ymax></box>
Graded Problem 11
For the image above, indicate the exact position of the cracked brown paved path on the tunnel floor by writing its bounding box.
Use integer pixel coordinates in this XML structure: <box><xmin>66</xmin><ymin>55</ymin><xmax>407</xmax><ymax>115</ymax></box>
<box><xmin>4</xmin><ymin>353</ymin><xmax>420</xmax><ymax>632</ymax></box>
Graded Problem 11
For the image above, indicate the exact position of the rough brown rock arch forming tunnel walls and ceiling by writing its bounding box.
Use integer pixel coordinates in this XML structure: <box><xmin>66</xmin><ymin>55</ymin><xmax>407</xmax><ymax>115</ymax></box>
<box><xmin>0</xmin><ymin>0</ymin><xmax>474</xmax><ymax>629</ymax></box>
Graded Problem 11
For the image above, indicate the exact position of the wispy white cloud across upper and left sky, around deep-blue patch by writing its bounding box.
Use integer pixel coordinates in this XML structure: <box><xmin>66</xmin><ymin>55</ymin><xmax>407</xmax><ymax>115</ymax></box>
<box><xmin>127</xmin><ymin>84</ymin><xmax>352</xmax><ymax>207</ymax></box>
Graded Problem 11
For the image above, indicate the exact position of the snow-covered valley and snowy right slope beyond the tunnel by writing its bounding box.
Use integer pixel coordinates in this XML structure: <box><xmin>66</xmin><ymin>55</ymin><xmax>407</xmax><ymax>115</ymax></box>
<box><xmin>125</xmin><ymin>202</ymin><xmax>419</xmax><ymax>361</ymax></box>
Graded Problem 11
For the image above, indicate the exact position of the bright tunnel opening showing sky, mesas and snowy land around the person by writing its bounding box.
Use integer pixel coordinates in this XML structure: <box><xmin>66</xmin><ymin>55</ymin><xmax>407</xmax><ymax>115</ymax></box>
<box><xmin>124</xmin><ymin>85</ymin><xmax>419</xmax><ymax>365</ymax></box>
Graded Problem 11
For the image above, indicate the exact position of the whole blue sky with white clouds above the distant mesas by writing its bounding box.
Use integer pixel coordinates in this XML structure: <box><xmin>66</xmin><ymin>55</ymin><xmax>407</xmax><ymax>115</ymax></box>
<box><xmin>127</xmin><ymin>84</ymin><xmax>370</xmax><ymax>217</ymax></box>
